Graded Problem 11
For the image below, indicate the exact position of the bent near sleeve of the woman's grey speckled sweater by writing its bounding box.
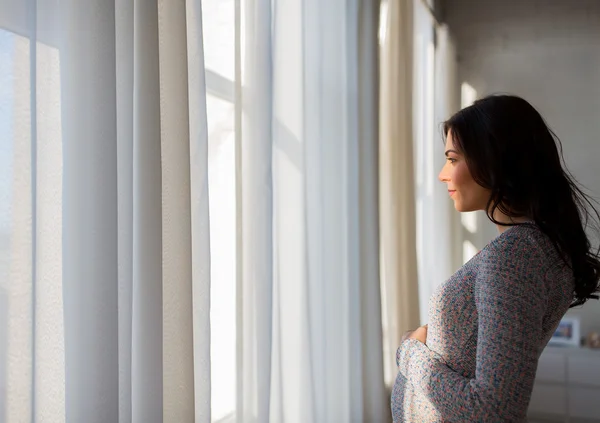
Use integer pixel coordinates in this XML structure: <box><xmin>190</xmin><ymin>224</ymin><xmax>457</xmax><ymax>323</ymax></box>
<box><xmin>397</xmin><ymin>237</ymin><xmax>546</xmax><ymax>423</ymax></box>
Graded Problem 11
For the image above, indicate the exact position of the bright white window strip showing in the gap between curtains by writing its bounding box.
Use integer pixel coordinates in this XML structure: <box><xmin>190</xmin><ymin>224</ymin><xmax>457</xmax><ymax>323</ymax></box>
<box><xmin>202</xmin><ymin>0</ymin><xmax>238</xmax><ymax>423</ymax></box>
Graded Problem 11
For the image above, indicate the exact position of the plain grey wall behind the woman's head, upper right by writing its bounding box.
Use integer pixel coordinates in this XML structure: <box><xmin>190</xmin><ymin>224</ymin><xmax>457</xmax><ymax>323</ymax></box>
<box><xmin>441</xmin><ymin>0</ymin><xmax>600</xmax><ymax>333</ymax></box>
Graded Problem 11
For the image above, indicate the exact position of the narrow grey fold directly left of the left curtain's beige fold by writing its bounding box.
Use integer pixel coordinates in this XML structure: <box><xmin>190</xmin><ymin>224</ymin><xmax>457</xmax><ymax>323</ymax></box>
<box><xmin>130</xmin><ymin>1</ymin><xmax>163</xmax><ymax>422</ymax></box>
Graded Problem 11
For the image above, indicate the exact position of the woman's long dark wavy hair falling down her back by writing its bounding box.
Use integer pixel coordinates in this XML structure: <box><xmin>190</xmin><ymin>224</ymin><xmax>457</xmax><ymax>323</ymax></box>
<box><xmin>443</xmin><ymin>95</ymin><xmax>600</xmax><ymax>307</ymax></box>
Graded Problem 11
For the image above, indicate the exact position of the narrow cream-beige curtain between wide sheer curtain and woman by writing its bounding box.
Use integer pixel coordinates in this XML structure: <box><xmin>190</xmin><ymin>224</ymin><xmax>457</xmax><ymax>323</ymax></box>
<box><xmin>379</xmin><ymin>0</ymin><xmax>420</xmax><ymax>387</ymax></box>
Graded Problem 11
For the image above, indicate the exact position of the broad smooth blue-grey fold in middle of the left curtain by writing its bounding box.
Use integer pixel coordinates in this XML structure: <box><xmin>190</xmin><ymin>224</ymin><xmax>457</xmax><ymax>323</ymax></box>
<box><xmin>61</xmin><ymin>1</ymin><xmax>119</xmax><ymax>422</ymax></box>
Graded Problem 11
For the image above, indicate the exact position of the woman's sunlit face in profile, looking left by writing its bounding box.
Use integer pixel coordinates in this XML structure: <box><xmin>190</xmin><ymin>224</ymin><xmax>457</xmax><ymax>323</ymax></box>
<box><xmin>439</xmin><ymin>131</ymin><xmax>491</xmax><ymax>212</ymax></box>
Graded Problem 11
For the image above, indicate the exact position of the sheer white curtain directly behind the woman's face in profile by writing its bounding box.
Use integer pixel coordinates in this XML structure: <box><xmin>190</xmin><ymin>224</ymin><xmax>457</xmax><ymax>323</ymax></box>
<box><xmin>414</xmin><ymin>0</ymin><xmax>462</xmax><ymax>324</ymax></box>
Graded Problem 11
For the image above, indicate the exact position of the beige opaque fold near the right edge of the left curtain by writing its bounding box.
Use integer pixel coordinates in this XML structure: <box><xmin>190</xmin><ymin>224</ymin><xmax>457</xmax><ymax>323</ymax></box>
<box><xmin>158</xmin><ymin>1</ymin><xmax>195</xmax><ymax>422</ymax></box>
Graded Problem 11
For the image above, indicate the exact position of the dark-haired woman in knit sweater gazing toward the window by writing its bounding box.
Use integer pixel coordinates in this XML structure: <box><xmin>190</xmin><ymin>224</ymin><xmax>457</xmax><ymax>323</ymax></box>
<box><xmin>392</xmin><ymin>96</ymin><xmax>600</xmax><ymax>423</ymax></box>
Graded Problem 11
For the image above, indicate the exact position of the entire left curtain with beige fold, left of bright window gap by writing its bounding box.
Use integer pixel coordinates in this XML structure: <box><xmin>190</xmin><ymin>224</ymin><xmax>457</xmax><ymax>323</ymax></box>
<box><xmin>0</xmin><ymin>0</ymin><xmax>210</xmax><ymax>423</ymax></box>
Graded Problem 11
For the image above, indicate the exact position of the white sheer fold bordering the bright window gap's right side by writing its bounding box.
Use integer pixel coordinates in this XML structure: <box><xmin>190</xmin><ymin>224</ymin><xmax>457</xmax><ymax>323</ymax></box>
<box><xmin>238</xmin><ymin>0</ymin><xmax>273</xmax><ymax>422</ymax></box>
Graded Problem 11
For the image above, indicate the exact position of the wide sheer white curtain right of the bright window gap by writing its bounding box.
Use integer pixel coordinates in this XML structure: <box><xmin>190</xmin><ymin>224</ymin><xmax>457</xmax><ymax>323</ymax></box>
<box><xmin>237</xmin><ymin>0</ymin><xmax>389</xmax><ymax>423</ymax></box>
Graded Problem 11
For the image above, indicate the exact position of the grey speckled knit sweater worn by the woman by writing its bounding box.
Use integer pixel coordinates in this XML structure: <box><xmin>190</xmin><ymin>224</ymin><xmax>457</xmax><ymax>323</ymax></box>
<box><xmin>392</xmin><ymin>224</ymin><xmax>573</xmax><ymax>423</ymax></box>
